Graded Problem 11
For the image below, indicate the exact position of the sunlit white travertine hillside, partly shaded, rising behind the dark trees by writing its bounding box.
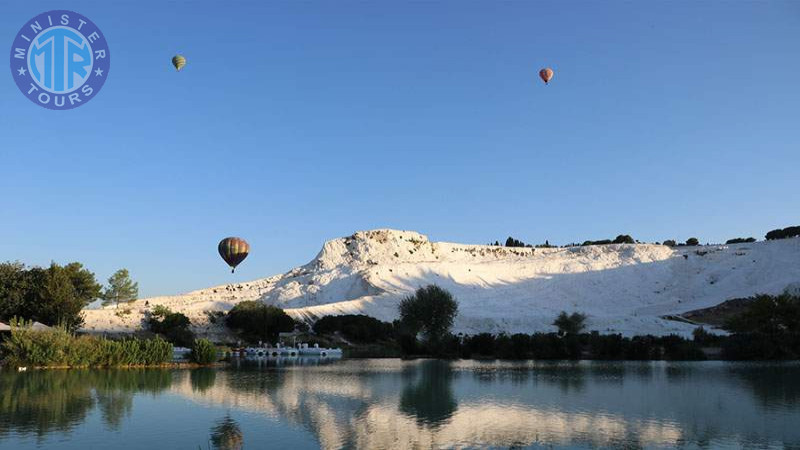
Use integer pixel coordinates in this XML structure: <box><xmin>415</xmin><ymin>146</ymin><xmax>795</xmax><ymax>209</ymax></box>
<box><xmin>85</xmin><ymin>229</ymin><xmax>800</xmax><ymax>335</ymax></box>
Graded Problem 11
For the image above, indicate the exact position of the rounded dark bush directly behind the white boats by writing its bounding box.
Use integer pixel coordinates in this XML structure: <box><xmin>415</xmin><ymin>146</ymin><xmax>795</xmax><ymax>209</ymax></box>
<box><xmin>225</xmin><ymin>301</ymin><xmax>295</xmax><ymax>342</ymax></box>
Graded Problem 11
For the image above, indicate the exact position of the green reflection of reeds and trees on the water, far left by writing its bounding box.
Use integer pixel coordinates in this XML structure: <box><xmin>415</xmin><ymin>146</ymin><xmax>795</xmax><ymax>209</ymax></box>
<box><xmin>0</xmin><ymin>370</ymin><xmax>172</xmax><ymax>436</ymax></box>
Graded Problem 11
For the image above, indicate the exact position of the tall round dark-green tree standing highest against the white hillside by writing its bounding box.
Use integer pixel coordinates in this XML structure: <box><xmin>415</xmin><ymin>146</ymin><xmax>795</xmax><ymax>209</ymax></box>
<box><xmin>399</xmin><ymin>284</ymin><xmax>458</xmax><ymax>343</ymax></box>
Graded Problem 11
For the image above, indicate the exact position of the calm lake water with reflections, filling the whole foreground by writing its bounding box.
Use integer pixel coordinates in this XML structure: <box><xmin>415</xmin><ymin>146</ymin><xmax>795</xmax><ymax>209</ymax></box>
<box><xmin>0</xmin><ymin>360</ymin><xmax>800</xmax><ymax>450</ymax></box>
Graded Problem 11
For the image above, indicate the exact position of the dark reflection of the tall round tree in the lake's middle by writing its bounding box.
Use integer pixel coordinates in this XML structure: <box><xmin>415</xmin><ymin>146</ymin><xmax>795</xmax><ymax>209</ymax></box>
<box><xmin>400</xmin><ymin>360</ymin><xmax>458</xmax><ymax>426</ymax></box>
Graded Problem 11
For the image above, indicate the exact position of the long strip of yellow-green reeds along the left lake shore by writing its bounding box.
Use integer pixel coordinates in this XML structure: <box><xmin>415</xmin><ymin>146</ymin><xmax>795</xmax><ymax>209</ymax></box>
<box><xmin>2</xmin><ymin>321</ymin><xmax>172</xmax><ymax>367</ymax></box>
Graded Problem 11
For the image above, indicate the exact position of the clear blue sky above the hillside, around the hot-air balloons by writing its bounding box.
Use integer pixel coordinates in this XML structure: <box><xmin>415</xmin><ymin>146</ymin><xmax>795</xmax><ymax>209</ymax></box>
<box><xmin>0</xmin><ymin>0</ymin><xmax>800</xmax><ymax>296</ymax></box>
